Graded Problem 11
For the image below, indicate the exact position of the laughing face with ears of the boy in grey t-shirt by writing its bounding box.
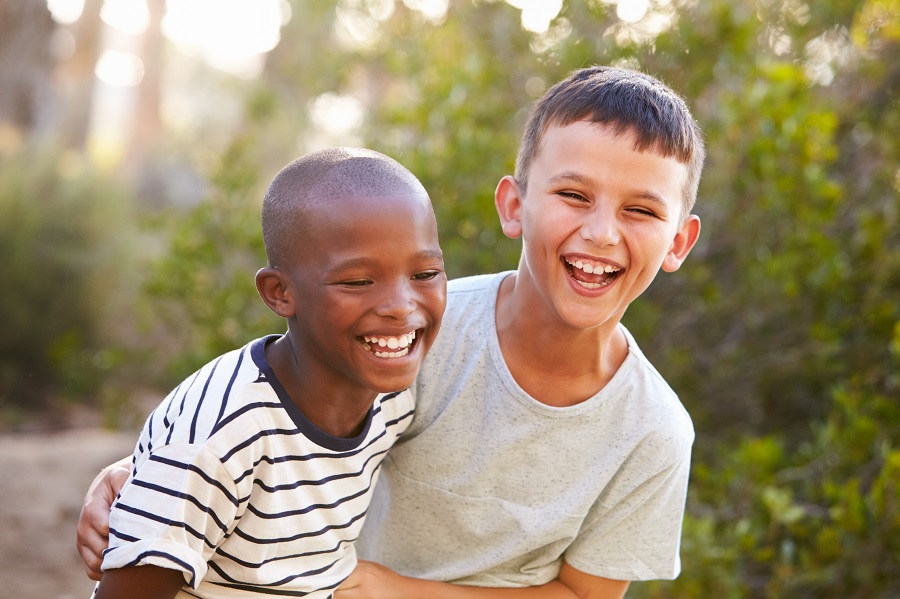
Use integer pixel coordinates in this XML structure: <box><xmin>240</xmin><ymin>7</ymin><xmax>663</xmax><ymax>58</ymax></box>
<box><xmin>496</xmin><ymin>121</ymin><xmax>700</xmax><ymax>329</ymax></box>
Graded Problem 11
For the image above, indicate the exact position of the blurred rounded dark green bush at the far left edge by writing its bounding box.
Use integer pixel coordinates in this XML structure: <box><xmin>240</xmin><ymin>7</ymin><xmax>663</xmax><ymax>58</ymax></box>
<box><xmin>0</xmin><ymin>148</ymin><xmax>132</xmax><ymax>419</ymax></box>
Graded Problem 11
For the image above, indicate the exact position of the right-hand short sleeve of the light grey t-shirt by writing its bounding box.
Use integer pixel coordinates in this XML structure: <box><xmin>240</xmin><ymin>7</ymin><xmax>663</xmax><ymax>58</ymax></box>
<box><xmin>565</xmin><ymin>450</ymin><xmax>690</xmax><ymax>580</ymax></box>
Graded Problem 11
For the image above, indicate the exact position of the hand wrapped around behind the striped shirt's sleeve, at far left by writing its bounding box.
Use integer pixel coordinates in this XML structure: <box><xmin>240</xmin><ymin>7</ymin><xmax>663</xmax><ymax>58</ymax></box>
<box><xmin>75</xmin><ymin>458</ymin><xmax>131</xmax><ymax>580</ymax></box>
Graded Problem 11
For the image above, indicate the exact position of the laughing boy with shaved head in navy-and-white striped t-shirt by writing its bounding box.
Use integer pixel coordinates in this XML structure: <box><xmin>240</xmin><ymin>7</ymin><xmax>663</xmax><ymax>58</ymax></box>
<box><xmin>89</xmin><ymin>148</ymin><xmax>446</xmax><ymax>599</ymax></box>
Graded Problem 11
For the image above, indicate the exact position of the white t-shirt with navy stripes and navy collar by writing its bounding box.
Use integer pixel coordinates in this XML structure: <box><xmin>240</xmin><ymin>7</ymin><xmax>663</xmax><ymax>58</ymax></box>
<box><xmin>103</xmin><ymin>336</ymin><xmax>413</xmax><ymax>599</ymax></box>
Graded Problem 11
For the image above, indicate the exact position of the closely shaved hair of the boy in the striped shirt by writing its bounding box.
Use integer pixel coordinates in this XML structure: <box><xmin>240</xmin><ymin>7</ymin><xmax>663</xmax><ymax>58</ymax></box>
<box><xmin>262</xmin><ymin>147</ymin><xmax>428</xmax><ymax>267</ymax></box>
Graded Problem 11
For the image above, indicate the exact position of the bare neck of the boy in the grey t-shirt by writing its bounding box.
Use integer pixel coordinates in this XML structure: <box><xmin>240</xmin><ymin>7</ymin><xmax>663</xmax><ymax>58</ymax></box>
<box><xmin>496</xmin><ymin>274</ymin><xmax>628</xmax><ymax>407</ymax></box>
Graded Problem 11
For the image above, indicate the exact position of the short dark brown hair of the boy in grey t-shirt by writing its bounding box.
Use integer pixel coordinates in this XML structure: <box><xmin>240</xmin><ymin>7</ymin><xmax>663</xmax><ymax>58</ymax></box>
<box><xmin>515</xmin><ymin>66</ymin><xmax>706</xmax><ymax>219</ymax></box>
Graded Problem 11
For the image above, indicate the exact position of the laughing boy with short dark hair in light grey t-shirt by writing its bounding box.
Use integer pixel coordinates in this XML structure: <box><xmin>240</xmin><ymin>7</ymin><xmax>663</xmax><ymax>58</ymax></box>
<box><xmin>337</xmin><ymin>67</ymin><xmax>704</xmax><ymax>599</ymax></box>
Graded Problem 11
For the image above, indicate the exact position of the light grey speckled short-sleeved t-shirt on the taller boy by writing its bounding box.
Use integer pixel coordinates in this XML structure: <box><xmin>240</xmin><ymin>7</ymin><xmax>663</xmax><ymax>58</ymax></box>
<box><xmin>357</xmin><ymin>273</ymin><xmax>694</xmax><ymax>587</ymax></box>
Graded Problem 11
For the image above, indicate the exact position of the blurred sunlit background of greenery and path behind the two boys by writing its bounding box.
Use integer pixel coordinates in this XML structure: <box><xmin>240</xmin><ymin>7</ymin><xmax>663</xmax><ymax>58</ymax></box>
<box><xmin>0</xmin><ymin>0</ymin><xmax>900</xmax><ymax>599</ymax></box>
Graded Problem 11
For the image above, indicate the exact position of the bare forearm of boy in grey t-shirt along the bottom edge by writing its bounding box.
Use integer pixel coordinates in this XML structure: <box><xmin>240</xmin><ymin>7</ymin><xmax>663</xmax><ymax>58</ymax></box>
<box><xmin>335</xmin><ymin>561</ymin><xmax>629</xmax><ymax>599</ymax></box>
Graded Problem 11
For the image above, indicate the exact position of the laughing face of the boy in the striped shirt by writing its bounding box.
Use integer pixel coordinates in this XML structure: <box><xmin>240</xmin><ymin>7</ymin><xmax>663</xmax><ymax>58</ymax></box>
<box><xmin>279</xmin><ymin>194</ymin><xmax>447</xmax><ymax>392</ymax></box>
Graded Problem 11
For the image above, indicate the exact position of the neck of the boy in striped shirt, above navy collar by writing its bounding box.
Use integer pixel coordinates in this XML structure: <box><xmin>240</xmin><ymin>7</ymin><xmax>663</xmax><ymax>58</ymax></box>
<box><xmin>265</xmin><ymin>334</ymin><xmax>378</xmax><ymax>438</ymax></box>
